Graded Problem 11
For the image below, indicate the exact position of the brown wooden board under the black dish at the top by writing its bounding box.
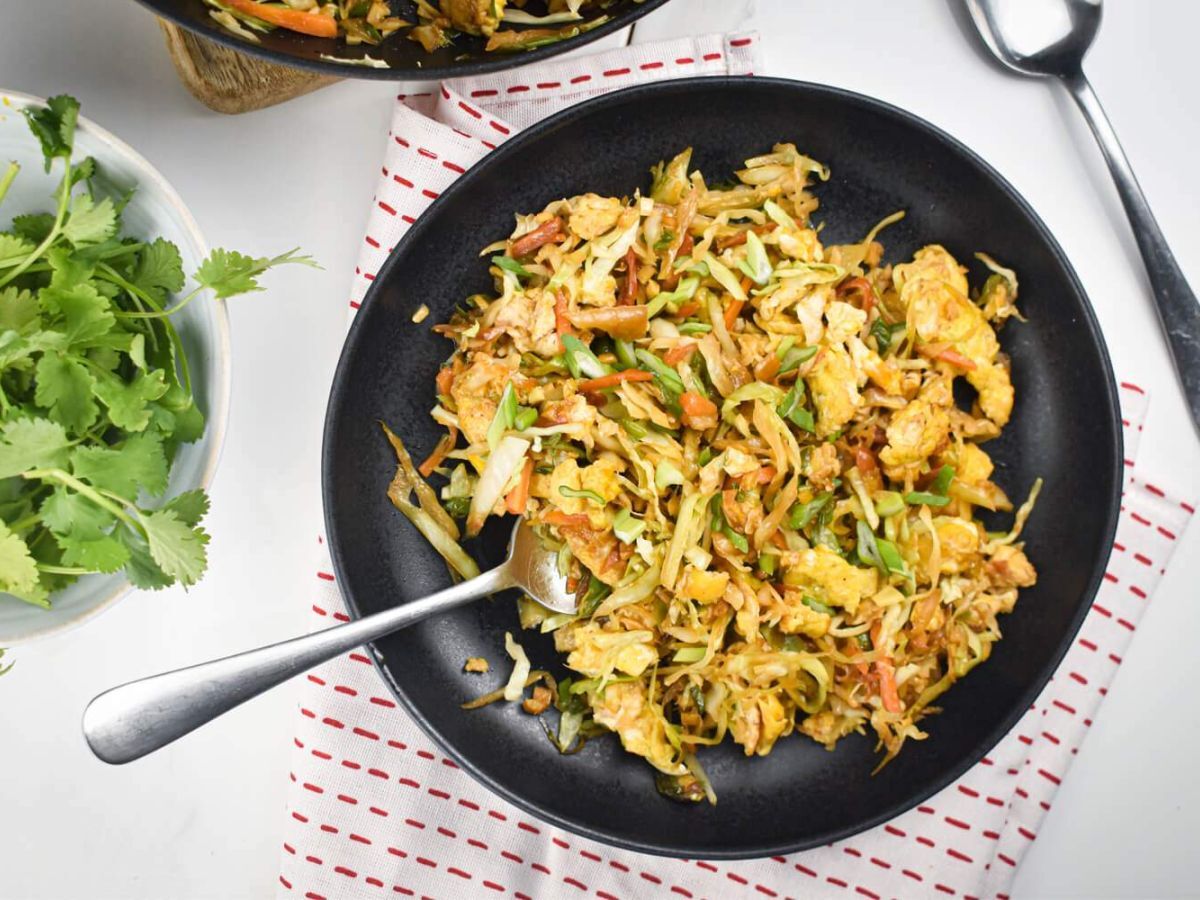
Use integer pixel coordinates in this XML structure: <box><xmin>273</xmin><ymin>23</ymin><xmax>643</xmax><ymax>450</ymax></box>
<box><xmin>158</xmin><ymin>19</ymin><xmax>341</xmax><ymax>114</ymax></box>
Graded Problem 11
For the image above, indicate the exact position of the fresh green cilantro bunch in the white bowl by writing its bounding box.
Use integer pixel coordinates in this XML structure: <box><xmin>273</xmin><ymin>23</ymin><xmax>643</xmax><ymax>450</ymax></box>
<box><xmin>0</xmin><ymin>96</ymin><xmax>312</xmax><ymax>607</ymax></box>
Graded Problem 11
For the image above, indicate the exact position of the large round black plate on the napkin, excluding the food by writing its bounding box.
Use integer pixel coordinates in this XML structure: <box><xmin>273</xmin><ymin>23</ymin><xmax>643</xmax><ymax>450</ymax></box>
<box><xmin>323</xmin><ymin>78</ymin><xmax>1122</xmax><ymax>858</ymax></box>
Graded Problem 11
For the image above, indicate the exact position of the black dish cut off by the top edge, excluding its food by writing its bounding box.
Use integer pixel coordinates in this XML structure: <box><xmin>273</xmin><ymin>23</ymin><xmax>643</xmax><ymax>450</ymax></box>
<box><xmin>138</xmin><ymin>0</ymin><xmax>667</xmax><ymax>82</ymax></box>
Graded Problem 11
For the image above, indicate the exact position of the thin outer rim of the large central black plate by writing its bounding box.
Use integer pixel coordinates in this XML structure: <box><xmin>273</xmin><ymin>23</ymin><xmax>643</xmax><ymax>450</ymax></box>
<box><xmin>322</xmin><ymin>76</ymin><xmax>1124</xmax><ymax>859</ymax></box>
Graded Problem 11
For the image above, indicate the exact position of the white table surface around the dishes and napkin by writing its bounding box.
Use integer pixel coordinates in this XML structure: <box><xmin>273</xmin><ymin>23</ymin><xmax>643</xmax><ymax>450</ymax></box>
<box><xmin>0</xmin><ymin>0</ymin><xmax>1200</xmax><ymax>900</ymax></box>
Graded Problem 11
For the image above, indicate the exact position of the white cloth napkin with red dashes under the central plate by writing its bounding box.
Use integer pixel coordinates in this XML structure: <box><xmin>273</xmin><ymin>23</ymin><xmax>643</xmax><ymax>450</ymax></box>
<box><xmin>278</xmin><ymin>34</ymin><xmax>1194</xmax><ymax>900</ymax></box>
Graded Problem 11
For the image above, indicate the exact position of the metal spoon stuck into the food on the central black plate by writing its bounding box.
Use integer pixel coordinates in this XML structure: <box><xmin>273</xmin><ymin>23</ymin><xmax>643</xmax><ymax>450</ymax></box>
<box><xmin>83</xmin><ymin>522</ymin><xmax>576</xmax><ymax>764</ymax></box>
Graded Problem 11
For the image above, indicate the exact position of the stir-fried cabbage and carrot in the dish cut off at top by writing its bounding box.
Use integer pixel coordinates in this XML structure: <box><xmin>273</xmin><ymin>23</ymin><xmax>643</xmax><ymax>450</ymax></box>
<box><xmin>204</xmin><ymin>0</ymin><xmax>613</xmax><ymax>56</ymax></box>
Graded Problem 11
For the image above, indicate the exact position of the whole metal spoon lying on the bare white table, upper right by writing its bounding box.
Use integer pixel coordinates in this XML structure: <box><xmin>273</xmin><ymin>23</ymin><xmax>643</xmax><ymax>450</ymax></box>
<box><xmin>964</xmin><ymin>0</ymin><xmax>1200</xmax><ymax>432</ymax></box>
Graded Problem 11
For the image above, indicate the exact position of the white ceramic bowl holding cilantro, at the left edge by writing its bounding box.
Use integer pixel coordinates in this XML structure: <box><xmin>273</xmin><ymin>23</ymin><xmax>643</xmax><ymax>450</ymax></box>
<box><xmin>0</xmin><ymin>90</ymin><xmax>230</xmax><ymax>647</ymax></box>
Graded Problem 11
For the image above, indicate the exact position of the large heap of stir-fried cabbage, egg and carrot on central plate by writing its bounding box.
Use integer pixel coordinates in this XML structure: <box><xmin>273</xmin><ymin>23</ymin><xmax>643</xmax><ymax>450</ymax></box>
<box><xmin>392</xmin><ymin>144</ymin><xmax>1040</xmax><ymax>799</ymax></box>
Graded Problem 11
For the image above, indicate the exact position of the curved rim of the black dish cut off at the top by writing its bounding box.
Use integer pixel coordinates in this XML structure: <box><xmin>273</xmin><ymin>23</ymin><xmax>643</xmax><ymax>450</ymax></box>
<box><xmin>138</xmin><ymin>0</ymin><xmax>668</xmax><ymax>83</ymax></box>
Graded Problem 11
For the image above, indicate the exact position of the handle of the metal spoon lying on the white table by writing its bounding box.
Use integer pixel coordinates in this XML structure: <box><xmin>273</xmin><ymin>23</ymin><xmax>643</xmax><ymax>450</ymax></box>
<box><xmin>1063</xmin><ymin>72</ymin><xmax>1200</xmax><ymax>431</ymax></box>
